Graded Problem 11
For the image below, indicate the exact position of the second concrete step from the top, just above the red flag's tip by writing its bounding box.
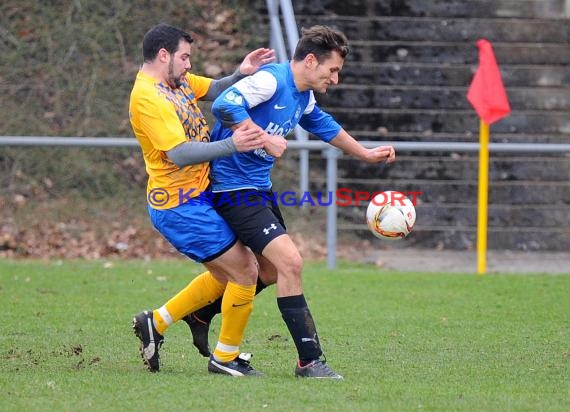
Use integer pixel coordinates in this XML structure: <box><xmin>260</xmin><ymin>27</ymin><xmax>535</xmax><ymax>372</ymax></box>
<box><xmin>297</xmin><ymin>16</ymin><xmax>570</xmax><ymax>45</ymax></box>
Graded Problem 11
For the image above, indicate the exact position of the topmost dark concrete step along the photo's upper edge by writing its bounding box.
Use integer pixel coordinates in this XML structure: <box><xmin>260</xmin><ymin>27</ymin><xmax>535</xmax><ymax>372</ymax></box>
<box><xmin>290</xmin><ymin>0</ymin><xmax>568</xmax><ymax>19</ymax></box>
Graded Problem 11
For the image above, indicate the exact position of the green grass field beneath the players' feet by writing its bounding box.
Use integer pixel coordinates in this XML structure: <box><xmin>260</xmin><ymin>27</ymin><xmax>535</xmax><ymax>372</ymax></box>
<box><xmin>0</xmin><ymin>259</ymin><xmax>570</xmax><ymax>412</ymax></box>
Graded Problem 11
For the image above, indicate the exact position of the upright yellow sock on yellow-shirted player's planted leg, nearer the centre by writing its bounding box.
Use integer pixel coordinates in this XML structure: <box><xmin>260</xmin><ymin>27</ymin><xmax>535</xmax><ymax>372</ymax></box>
<box><xmin>214</xmin><ymin>282</ymin><xmax>255</xmax><ymax>362</ymax></box>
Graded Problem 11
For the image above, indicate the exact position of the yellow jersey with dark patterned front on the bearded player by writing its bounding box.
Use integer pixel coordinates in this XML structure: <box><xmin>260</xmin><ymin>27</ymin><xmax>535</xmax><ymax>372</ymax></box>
<box><xmin>129</xmin><ymin>72</ymin><xmax>212</xmax><ymax>209</ymax></box>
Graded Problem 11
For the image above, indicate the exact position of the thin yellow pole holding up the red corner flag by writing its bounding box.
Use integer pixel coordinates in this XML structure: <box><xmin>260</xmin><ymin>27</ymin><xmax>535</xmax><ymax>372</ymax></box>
<box><xmin>477</xmin><ymin>119</ymin><xmax>489</xmax><ymax>275</ymax></box>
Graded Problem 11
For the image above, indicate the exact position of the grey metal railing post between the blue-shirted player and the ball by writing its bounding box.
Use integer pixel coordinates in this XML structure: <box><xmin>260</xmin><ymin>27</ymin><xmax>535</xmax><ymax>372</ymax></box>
<box><xmin>324</xmin><ymin>146</ymin><xmax>340</xmax><ymax>269</ymax></box>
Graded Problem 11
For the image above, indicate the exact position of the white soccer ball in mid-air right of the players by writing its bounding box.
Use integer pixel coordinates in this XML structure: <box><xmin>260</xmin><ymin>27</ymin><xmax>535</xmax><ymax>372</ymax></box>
<box><xmin>366</xmin><ymin>190</ymin><xmax>416</xmax><ymax>240</ymax></box>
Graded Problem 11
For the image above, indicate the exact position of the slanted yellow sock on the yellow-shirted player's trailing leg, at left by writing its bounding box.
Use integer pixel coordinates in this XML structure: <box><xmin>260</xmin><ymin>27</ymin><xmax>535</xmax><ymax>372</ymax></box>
<box><xmin>152</xmin><ymin>272</ymin><xmax>225</xmax><ymax>335</ymax></box>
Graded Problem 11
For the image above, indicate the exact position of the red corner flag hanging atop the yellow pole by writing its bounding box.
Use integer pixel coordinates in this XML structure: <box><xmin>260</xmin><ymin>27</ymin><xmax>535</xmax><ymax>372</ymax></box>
<box><xmin>467</xmin><ymin>39</ymin><xmax>511</xmax><ymax>124</ymax></box>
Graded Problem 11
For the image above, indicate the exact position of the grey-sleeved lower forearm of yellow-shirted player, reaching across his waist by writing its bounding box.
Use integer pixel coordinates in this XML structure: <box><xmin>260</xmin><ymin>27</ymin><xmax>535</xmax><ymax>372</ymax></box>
<box><xmin>166</xmin><ymin>138</ymin><xmax>237</xmax><ymax>167</ymax></box>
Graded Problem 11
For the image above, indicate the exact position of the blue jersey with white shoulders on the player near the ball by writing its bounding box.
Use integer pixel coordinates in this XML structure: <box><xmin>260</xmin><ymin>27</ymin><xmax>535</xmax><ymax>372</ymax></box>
<box><xmin>210</xmin><ymin>63</ymin><xmax>341</xmax><ymax>192</ymax></box>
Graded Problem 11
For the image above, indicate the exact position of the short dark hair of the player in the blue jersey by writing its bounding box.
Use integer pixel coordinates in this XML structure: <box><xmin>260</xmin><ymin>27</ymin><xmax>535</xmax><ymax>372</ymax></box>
<box><xmin>293</xmin><ymin>26</ymin><xmax>350</xmax><ymax>63</ymax></box>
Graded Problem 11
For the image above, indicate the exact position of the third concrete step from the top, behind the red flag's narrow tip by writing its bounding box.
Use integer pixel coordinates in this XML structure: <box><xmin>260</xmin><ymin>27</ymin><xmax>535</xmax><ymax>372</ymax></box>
<box><xmin>349</xmin><ymin>40</ymin><xmax>570</xmax><ymax>67</ymax></box>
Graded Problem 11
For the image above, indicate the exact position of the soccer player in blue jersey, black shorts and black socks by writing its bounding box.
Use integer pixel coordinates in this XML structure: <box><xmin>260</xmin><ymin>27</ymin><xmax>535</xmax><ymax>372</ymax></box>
<box><xmin>185</xmin><ymin>26</ymin><xmax>395</xmax><ymax>379</ymax></box>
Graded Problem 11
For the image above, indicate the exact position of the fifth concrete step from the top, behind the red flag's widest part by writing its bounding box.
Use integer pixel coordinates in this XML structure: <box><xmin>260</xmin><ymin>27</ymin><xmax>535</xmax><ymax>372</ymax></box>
<box><xmin>319</xmin><ymin>84</ymin><xmax>570</xmax><ymax>111</ymax></box>
